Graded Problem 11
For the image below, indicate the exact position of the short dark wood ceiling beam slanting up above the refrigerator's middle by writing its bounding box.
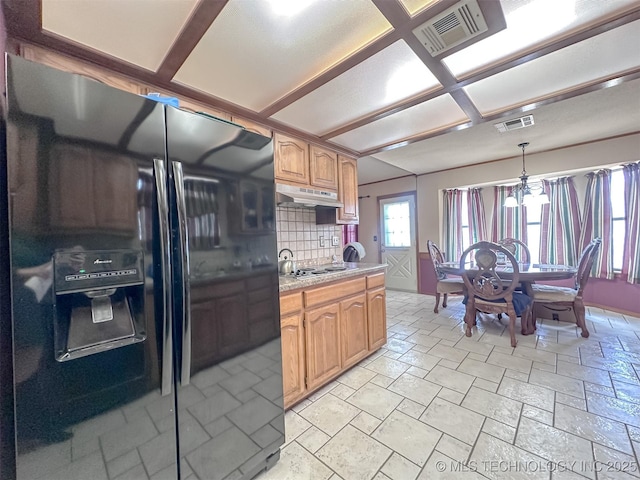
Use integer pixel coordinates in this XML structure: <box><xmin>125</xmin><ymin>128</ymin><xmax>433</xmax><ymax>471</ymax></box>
<box><xmin>157</xmin><ymin>0</ymin><xmax>228</xmax><ymax>82</ymax></box>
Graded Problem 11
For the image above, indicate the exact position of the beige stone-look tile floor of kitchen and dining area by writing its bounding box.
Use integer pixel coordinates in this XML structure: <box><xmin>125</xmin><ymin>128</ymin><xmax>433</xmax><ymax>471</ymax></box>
<box><xmin>258</xmin><ymin>291</ymin><xmax>640</xmax><ymax>480</ymax></box>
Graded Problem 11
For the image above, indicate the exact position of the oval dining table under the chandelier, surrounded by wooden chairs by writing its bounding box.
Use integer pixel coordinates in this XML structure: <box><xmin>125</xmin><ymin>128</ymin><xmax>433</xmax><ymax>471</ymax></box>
<box><xmin>439</xmin><ymin>262</ymin><xmax>578</xmax><ymax>335</ymax></box>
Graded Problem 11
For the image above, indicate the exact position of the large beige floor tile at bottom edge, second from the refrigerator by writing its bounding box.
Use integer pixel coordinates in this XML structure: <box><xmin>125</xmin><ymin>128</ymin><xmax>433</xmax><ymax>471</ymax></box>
<box><xmin>316</xmin><ymin>425</ymin><xmax>392</xmax><ymax>480</ymax></box>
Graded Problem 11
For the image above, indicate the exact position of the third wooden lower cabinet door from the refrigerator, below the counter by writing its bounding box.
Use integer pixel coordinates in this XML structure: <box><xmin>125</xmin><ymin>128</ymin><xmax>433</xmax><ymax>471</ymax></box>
<box><xmin>340</xmin><ymin>293</ymin><xmax>369</xmax><ymax>368</ymax></box>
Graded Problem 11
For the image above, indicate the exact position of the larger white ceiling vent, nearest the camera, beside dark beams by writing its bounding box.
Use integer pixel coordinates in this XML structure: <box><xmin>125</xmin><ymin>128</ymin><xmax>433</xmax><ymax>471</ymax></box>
<box><xmin>413</xmin><ymin>0</ymin><xmax>487</xmax><ymax>57</ymax></box>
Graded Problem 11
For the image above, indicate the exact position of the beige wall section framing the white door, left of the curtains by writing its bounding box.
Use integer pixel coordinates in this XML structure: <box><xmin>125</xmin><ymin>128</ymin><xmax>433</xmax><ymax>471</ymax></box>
<box><xmin>358</xmin><ymin>176</ymin><xmax>420</xmax><ymax>263</ymax></box>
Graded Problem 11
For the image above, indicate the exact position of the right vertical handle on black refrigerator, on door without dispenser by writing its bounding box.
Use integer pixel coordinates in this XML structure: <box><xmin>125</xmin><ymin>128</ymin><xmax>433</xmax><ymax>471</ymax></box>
<box><xmin>173</xmin><ymin>162</ymin><xmax>191</xmax><ymax>386</ymax></box>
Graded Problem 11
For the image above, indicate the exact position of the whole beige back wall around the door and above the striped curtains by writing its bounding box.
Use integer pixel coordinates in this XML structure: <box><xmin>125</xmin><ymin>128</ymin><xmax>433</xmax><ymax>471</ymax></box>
<box><xmin>358</xmin><ymin>134</ymin><xmax>640</xmax><ymax>255</ymax></box>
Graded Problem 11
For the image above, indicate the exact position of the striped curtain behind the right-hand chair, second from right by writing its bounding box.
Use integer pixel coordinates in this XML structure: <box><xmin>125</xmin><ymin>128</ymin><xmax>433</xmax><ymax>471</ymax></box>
<box><xmin>580</xmin><ymin>170</ymin><xmax>613</xmax><ymax>279</ymax></box>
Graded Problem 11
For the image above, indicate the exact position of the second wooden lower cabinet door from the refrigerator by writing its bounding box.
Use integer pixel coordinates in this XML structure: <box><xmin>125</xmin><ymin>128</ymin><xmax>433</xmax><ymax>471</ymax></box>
<box><xmin>304</xmin><ymin>303</ymin><xmax>341</xmax><ymax>389</ymax></box>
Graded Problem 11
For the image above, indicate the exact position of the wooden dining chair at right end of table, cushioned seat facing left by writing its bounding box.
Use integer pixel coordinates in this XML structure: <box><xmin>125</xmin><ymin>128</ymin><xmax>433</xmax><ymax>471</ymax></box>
<box><xmin>529</xmin><ymin>238</ymin><xmax>602</xmax><ymax>338</ymax></box>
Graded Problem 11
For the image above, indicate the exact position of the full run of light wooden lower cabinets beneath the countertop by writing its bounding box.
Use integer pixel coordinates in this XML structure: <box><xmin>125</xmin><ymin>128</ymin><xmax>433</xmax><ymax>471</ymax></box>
<box><xmin>280</xmin><ymin>273</ymin><xmax>387</xmax><ymax>408</ymax></box>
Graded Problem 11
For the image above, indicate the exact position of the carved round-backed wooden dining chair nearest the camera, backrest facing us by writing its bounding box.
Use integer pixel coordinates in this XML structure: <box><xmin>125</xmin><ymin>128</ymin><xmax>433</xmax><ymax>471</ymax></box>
<box><xmin>460</xmin><ymin>242</ymin><xmax>532</xmax><ymax>347</ymax></box>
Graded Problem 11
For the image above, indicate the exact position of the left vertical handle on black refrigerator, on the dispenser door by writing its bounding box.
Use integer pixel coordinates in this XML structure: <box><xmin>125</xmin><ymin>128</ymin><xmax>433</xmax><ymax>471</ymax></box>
<box><xmin>153</xmin><ymin>158</ymin><xmax>173</xmax><ymax>395</ymax></box>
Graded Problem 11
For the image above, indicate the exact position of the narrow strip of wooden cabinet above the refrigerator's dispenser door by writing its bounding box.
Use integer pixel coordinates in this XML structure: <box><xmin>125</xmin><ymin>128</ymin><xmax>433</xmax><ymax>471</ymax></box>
<box><xmin>20</xmin><ymin>44</ymin><xmax>148</xmax><ymax>94</ymax></box>
